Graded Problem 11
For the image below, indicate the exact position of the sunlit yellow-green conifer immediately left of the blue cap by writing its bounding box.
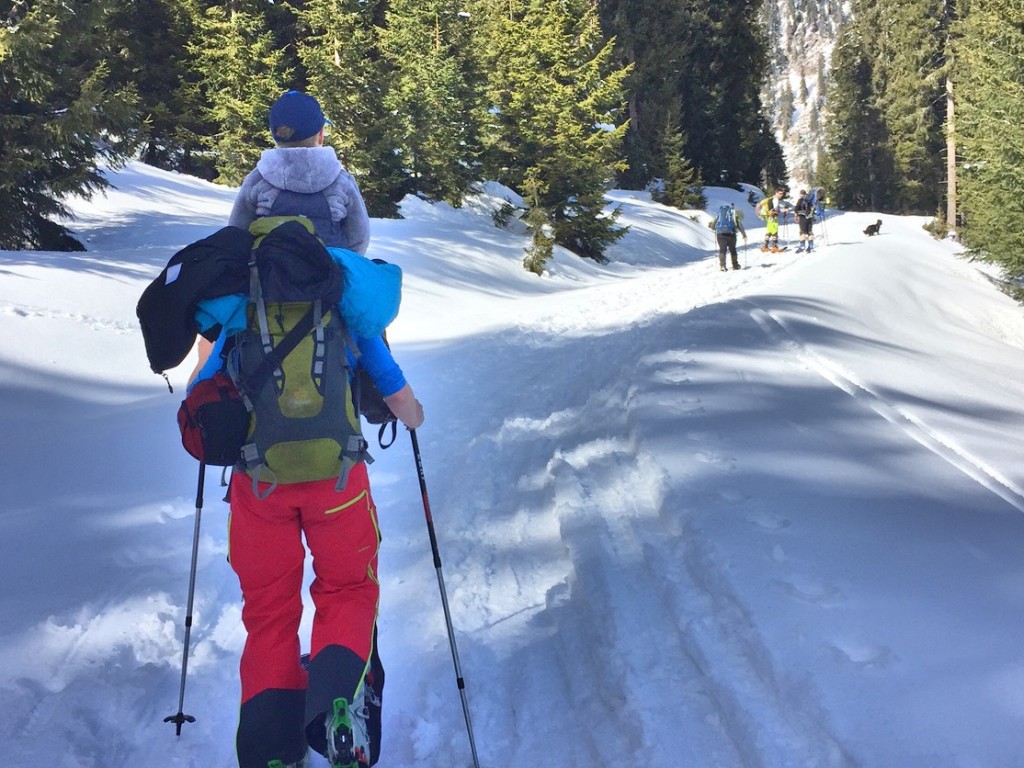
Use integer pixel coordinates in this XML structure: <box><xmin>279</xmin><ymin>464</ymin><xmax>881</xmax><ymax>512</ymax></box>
<box><xmin>187</xmin><ymin>0</ymin><xmax>291</xmax><ymax>185</ymax></box>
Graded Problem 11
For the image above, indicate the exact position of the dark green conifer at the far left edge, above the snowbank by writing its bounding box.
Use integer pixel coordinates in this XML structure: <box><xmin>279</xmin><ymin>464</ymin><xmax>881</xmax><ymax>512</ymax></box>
<box><xmin>0</xmin><ymin>0</ymin><xmax>137</xmax><ymax>250</ymax></box>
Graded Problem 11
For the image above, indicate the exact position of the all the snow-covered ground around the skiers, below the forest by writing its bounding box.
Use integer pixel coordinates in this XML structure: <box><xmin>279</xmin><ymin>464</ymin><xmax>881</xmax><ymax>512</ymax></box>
<box><xmin>0</xmin><ymin>164</ymin><xmax>1024</xmax><ymax>768</ymax></box>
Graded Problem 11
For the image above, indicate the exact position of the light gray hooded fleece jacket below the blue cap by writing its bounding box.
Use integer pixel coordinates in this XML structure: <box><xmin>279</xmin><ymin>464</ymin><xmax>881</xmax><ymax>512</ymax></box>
<box><xmin>227</xmin><ymin>146</ymin><xmax>370</xmax><ymax>255</ymax></box>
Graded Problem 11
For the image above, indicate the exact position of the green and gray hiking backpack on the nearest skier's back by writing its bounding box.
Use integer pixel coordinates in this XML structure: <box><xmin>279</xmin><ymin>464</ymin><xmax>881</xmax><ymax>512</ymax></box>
<box><xmin>227</xmin><ymin>217</ymin><xmax>373</xmax><ymax>497</ymax></box>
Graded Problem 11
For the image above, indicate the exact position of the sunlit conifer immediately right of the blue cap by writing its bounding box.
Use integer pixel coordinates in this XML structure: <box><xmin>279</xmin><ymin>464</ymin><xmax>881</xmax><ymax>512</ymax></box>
<box><xmin>299</xmin><ymin>0</ymin><xmax>411</xmax><ymax>217</ymax></box>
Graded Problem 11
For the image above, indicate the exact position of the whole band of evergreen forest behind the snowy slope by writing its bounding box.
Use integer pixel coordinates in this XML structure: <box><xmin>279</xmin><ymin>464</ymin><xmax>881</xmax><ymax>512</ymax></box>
<box><xmin>0</xmin><ymin>0</ymin><xmax>1024</xmax><ymax>278</ymax></box>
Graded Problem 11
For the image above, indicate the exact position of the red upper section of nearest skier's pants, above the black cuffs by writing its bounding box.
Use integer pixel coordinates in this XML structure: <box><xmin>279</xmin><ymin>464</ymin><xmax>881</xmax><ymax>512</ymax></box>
<box><xmin>228</xmin><ymin>463</ymin><xmax>380</xmax><ymax>703</ymax></box>
